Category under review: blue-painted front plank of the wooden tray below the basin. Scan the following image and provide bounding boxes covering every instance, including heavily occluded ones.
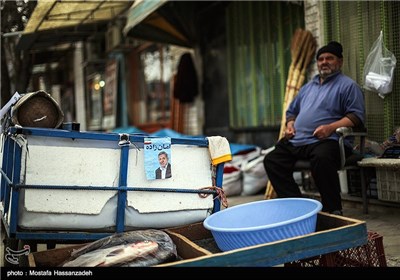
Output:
[165,224,367,267]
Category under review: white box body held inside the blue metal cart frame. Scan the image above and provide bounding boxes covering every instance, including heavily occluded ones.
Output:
[14,132,214,229]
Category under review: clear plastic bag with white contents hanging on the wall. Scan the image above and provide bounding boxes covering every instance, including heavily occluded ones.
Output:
[364,31,396,98]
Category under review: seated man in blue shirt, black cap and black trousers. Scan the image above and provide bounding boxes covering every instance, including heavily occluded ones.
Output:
[264,41,365,215]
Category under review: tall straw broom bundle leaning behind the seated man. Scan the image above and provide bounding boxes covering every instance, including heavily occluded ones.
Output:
[265,28,316,199]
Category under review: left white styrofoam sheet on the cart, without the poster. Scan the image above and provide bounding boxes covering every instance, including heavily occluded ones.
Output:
[21,136,120,214]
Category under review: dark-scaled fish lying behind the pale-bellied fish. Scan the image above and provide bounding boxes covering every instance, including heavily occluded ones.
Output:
[61,229,178,266]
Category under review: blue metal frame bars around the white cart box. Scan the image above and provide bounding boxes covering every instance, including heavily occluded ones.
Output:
[0,127,224,262]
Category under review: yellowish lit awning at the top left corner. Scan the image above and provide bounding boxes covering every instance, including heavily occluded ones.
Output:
[18,0,133,50]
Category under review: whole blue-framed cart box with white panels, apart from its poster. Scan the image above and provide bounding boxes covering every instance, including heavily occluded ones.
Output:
[1,127,223,244]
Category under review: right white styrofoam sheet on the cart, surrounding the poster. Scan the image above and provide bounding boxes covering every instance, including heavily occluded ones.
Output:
[127,144,213,213]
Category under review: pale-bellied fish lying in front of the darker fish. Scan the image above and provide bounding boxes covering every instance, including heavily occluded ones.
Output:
[63,241,158,267]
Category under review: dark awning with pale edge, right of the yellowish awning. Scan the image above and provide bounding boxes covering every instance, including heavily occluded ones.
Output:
[123,0,192,47]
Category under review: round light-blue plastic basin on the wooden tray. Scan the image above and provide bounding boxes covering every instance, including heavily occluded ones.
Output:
[203,198,322,251]
